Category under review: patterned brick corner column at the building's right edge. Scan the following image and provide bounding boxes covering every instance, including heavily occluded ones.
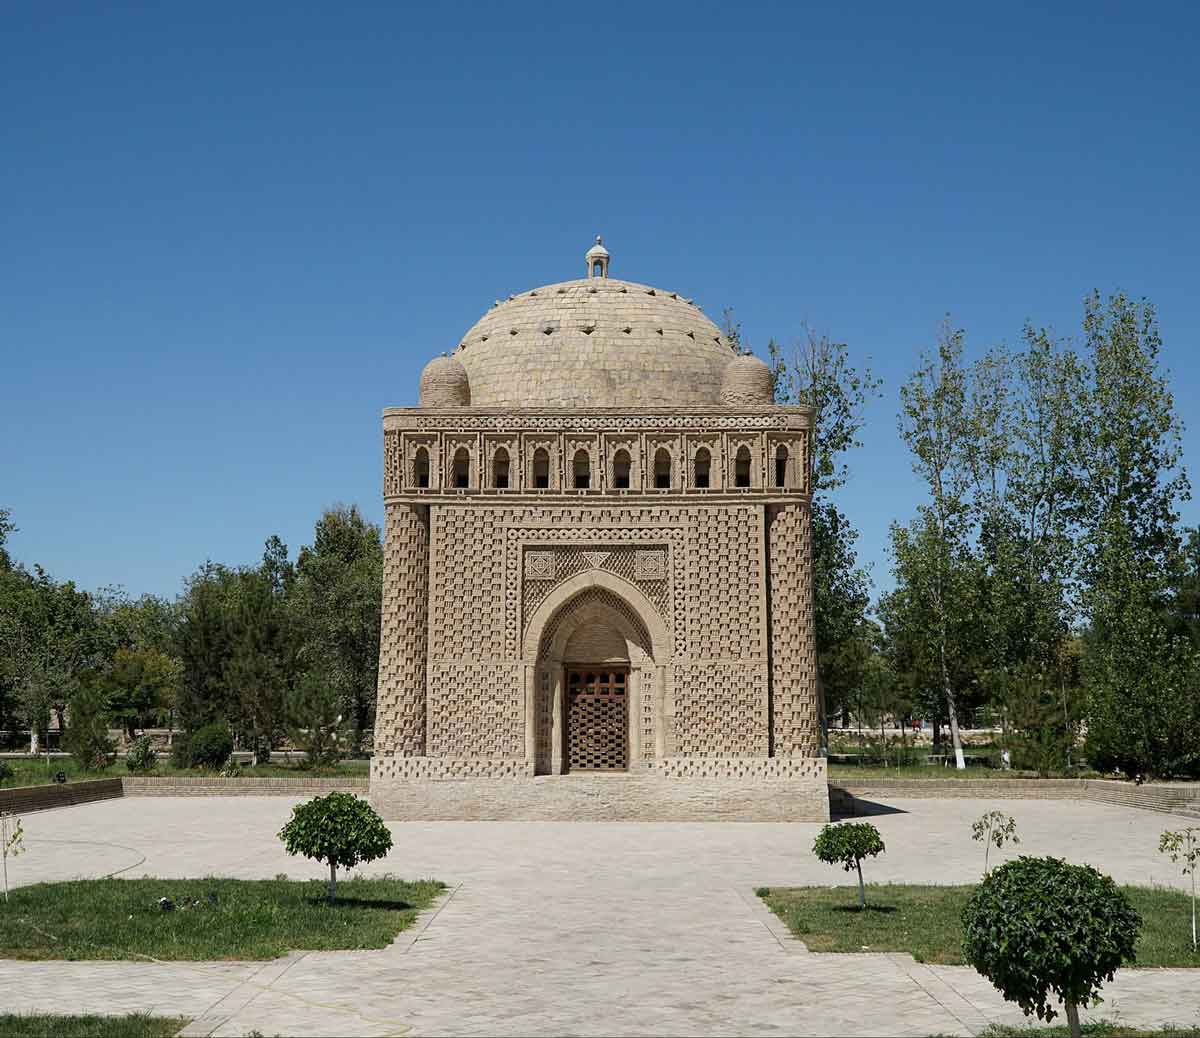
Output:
[767,504,820,757]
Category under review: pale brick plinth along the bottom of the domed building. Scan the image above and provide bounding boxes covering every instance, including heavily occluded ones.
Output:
[371,757,829,822]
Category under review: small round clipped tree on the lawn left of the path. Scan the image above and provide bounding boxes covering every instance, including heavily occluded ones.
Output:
[280,793,391,902]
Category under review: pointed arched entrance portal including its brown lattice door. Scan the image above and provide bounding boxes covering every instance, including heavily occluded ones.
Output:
[523,571,670,775]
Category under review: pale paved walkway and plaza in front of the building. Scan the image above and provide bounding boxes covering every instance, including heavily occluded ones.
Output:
[0,797,1200,1036]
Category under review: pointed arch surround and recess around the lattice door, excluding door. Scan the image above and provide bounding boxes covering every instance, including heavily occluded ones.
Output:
[521,570,671,775]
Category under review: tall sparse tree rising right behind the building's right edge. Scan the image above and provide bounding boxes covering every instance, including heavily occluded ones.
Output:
[768,328,882,724]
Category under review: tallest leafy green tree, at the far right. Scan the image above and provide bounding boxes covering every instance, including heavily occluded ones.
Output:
[1074,293,1200,775]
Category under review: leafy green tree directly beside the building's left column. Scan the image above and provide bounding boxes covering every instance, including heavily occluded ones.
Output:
[288,505,383,744]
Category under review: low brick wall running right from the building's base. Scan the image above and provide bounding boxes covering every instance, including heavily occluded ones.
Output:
[829,779,1200,817]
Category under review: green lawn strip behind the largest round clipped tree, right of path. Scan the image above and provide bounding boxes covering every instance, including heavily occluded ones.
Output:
[757,884,1200,967]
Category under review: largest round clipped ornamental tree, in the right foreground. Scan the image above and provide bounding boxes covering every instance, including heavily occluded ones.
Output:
[962,856,1141,1038]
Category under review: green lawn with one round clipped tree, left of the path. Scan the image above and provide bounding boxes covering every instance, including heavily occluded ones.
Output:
[0,877,445,960]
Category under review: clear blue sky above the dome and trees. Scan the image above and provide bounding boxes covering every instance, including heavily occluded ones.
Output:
[0,0,1200,595]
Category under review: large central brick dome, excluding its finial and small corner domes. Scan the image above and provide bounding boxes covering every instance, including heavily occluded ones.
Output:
[452,276,733,408]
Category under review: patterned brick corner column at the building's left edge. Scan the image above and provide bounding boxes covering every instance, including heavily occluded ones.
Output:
[374,504,430,760]
